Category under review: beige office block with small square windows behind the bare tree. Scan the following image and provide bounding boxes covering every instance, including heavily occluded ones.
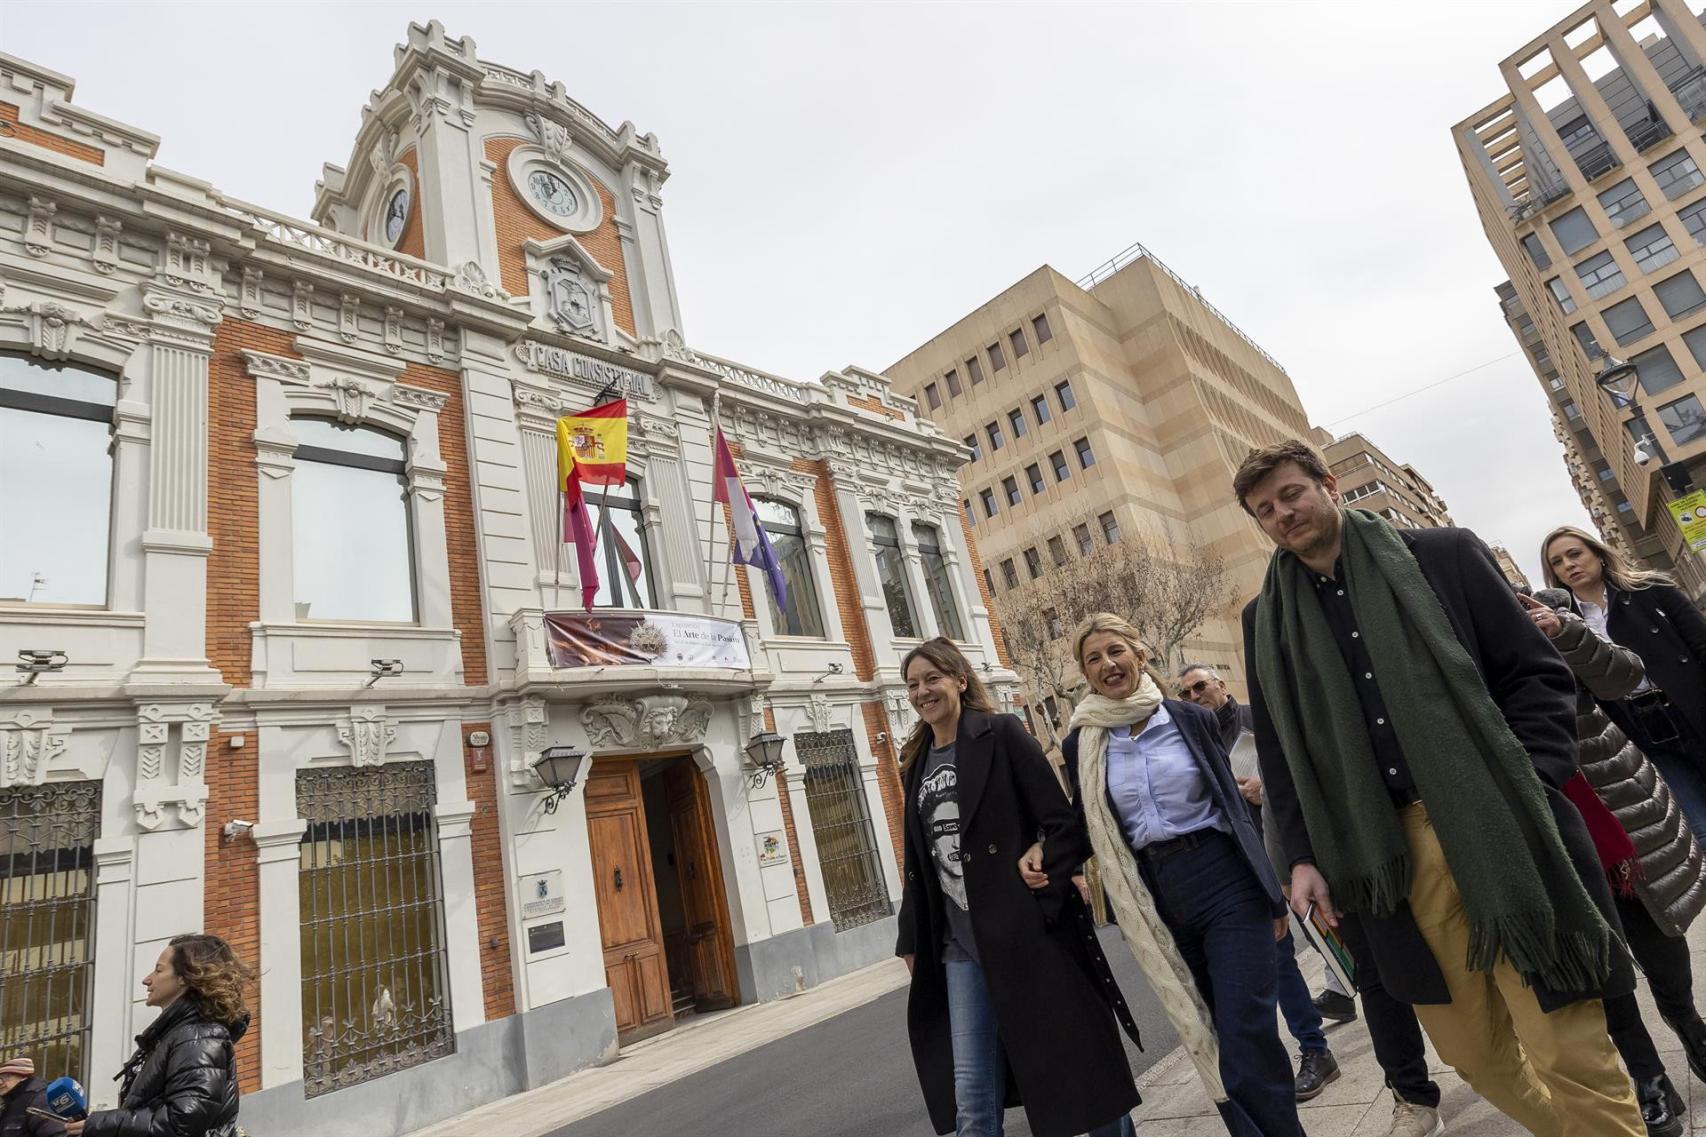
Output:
[887,246,1310,683]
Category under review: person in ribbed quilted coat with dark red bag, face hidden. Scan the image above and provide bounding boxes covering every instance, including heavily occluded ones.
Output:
[1523,589,1706,1134]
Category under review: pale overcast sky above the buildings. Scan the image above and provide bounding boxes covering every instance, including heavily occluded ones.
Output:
[0,0,1585,575]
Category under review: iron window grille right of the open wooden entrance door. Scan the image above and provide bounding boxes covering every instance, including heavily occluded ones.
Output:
[793,731,894,932]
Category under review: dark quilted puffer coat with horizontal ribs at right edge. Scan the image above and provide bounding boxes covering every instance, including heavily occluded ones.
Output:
[1552,611,1706,936]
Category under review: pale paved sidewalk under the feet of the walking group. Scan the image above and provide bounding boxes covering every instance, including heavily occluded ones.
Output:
[1131,922,1706,1137]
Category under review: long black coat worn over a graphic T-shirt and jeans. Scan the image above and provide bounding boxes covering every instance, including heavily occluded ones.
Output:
[894,710,1141,1137]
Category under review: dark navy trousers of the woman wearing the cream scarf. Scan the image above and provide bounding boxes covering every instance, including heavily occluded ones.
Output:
[1138,830,1303,1137]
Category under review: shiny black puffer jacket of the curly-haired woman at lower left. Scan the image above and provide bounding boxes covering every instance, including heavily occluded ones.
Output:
[84,997,249,1137]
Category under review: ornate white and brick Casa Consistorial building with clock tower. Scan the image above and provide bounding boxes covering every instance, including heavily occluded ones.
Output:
[0,24,1015,1137]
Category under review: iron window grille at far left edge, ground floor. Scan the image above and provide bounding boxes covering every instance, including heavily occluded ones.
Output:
[0,782,101,1084]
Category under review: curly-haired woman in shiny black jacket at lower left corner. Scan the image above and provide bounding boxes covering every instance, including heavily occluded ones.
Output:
[65,936,251,1137]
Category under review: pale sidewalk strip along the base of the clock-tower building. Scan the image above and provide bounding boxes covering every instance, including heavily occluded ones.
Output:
[409,959,908,1137]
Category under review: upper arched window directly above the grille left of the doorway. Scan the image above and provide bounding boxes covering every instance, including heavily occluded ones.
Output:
[290,418,415,623]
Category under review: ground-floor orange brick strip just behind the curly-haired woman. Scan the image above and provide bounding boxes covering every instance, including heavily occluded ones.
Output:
[203,727,259,1094]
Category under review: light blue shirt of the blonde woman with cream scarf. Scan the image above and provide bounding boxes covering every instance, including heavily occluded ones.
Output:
[1107,707,1228,848]
